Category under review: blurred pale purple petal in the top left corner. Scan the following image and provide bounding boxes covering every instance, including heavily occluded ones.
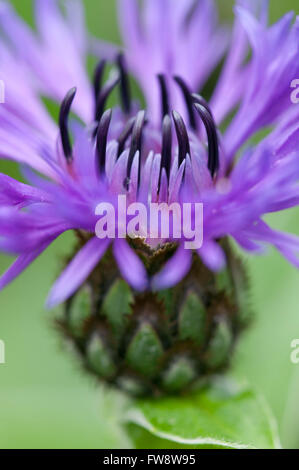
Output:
[0,0,93,122]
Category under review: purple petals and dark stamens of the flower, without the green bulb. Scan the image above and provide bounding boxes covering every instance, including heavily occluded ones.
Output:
[0,0,299,307]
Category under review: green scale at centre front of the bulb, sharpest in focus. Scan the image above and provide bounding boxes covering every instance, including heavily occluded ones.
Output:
[126,323,163,377]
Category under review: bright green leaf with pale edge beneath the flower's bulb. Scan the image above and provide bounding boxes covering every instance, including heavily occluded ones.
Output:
[125,379,280,449]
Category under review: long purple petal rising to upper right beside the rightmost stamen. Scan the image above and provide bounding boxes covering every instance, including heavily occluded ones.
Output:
[224,7,299,161]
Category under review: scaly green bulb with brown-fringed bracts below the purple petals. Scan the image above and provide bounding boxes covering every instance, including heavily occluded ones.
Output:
[57,240,250,396]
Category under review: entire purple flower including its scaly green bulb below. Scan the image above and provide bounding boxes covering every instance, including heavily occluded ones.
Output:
[0,0,299,393]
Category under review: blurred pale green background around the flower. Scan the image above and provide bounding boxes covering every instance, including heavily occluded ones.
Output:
[0,0,299,448]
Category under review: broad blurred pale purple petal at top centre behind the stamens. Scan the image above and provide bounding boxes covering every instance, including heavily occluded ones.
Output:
[118,0,228,124]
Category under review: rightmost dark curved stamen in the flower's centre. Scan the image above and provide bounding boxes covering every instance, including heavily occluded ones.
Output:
[194,103,219,178]
